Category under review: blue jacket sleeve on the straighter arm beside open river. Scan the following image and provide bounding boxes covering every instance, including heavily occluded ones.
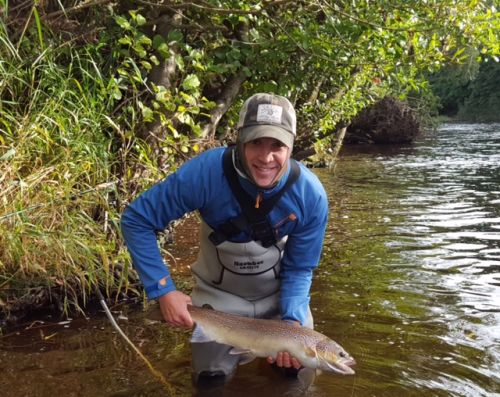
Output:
[280,176,328,325]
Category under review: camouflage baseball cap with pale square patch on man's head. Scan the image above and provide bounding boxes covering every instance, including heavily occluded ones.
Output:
[236,93,297,148]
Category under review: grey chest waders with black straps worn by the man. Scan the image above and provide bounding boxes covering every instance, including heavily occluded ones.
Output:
[191,147,312,382]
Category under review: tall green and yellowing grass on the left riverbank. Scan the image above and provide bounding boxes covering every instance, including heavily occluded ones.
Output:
[0,22,148,322]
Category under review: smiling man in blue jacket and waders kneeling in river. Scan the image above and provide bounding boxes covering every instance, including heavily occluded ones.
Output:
[121,94,328,382]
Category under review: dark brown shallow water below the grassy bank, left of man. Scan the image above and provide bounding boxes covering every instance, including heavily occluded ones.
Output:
[0,305,190,397]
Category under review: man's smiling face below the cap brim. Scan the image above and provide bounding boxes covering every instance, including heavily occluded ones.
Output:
[244,138,289,188]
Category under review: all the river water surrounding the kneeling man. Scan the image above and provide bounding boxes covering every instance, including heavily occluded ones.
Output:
[0,124,500,397]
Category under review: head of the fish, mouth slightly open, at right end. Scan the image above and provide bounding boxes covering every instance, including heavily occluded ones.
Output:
[316,339,356,375]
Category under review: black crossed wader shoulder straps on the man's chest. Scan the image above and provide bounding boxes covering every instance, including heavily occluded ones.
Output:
[209,146,300,247]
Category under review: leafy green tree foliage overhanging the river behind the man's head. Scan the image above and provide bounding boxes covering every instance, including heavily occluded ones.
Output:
[103,0,498,150]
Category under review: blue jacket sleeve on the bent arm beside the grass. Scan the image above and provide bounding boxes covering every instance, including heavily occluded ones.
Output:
[121,150,218,299]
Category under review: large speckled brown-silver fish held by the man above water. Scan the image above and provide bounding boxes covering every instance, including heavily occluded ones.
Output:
[188,305,356,375]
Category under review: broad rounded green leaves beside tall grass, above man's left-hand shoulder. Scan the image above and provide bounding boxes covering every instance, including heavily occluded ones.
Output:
[110,10,213,155]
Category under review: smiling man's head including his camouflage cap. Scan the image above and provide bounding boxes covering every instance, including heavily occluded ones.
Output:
[236,94,296,188]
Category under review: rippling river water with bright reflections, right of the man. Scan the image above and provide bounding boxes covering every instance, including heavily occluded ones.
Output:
[315,125,500,396]
